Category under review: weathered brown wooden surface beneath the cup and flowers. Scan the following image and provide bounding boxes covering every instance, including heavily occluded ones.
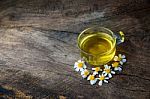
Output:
[0,0,150,99]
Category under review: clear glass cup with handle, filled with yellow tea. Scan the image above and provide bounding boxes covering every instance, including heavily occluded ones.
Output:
[77,27,124,66]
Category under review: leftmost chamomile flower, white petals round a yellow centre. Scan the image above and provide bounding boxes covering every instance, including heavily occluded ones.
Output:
[74,60,86,71]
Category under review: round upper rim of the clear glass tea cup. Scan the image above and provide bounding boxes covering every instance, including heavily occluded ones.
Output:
[77,26,116,56]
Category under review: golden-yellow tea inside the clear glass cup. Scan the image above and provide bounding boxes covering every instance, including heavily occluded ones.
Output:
[79,33,116,65]
